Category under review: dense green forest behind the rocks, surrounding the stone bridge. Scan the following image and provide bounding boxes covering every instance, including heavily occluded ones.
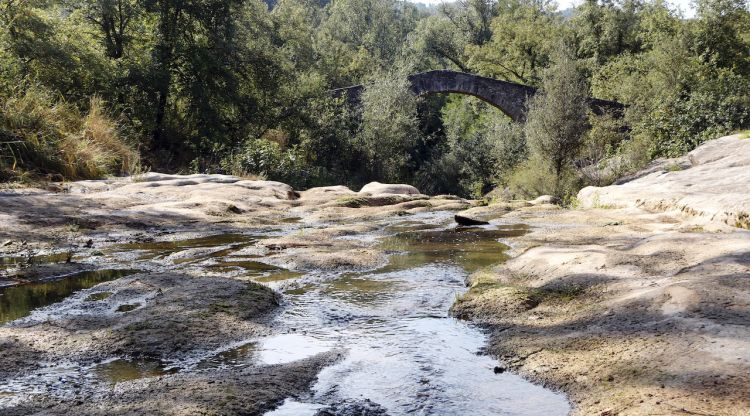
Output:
[0,0,750,197]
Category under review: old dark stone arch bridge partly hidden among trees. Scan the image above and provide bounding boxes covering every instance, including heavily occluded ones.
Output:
[332,70,624,121]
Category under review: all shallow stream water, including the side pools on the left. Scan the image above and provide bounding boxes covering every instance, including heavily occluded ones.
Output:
[0,213,570,416]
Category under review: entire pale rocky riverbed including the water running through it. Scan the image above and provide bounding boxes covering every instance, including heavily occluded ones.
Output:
[0,137,750,415]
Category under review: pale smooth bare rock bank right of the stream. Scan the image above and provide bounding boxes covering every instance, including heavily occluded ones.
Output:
[452,138,750,415]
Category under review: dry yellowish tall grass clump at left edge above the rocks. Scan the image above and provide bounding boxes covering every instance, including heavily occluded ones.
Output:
[0,87,140,180]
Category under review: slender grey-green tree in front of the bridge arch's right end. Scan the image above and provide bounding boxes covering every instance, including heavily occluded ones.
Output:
[525,47,588,196]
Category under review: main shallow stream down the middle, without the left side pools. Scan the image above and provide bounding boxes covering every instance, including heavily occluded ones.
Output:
[257,216,569,415]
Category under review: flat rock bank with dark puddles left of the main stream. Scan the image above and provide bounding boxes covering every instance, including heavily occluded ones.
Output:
[0,173,482,415]
